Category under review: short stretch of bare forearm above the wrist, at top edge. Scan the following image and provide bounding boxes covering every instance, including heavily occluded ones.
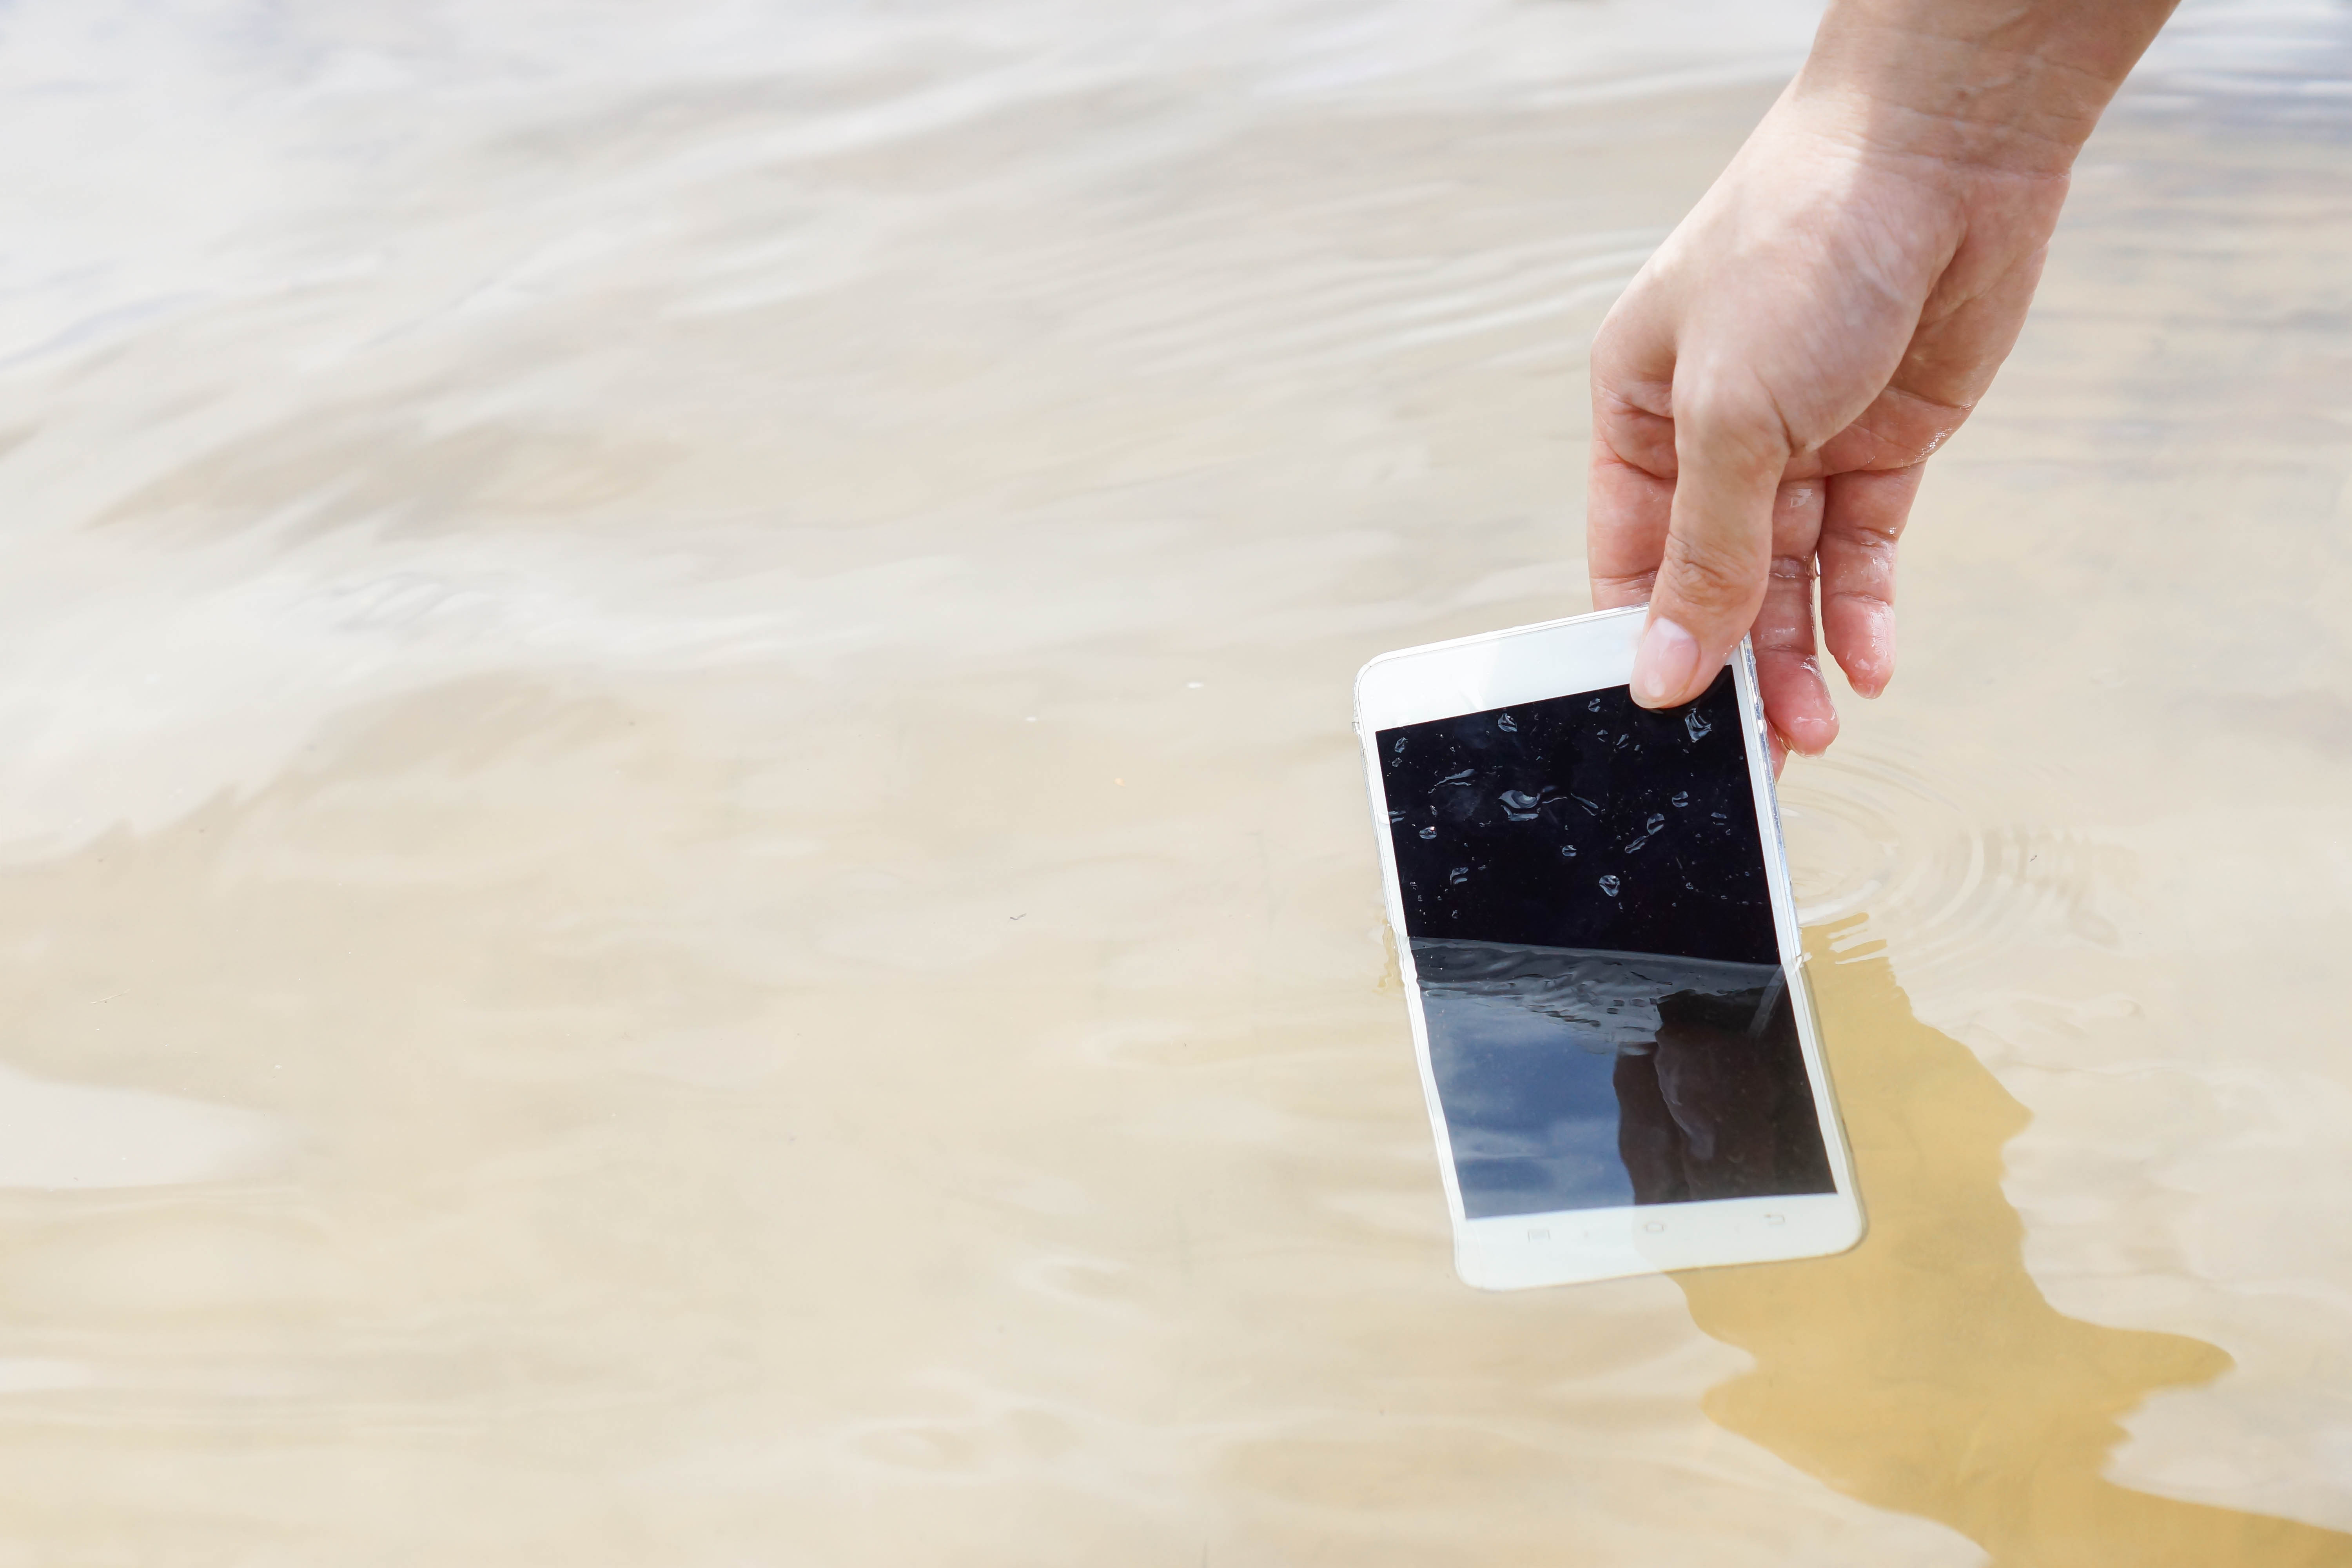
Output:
[1790,0,2176,176]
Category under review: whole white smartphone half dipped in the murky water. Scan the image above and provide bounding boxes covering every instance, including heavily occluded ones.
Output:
[1355,609,1863,1290]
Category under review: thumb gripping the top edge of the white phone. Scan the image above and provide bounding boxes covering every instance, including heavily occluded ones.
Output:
[1632,388,1790,708]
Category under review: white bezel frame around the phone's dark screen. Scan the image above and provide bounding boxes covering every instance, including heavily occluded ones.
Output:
[1355,606,1863,1290]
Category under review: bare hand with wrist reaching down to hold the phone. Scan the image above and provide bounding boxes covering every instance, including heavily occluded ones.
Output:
[1585,0,2171,766]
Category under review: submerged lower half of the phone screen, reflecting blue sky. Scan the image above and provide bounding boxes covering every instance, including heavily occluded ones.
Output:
[1414,938,1835,1220]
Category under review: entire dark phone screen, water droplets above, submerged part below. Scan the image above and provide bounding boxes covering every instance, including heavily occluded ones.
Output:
[1378,670,1837,1220]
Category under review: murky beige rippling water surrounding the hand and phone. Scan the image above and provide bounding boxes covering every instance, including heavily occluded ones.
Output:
[0,0,2352,1568]
